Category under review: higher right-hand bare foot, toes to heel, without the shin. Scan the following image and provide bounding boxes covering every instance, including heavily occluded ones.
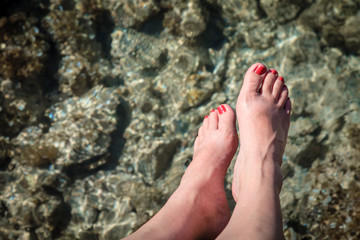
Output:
[232,63,291,201]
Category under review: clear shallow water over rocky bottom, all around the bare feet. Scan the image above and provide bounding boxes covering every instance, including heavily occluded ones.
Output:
[0,1,360,239]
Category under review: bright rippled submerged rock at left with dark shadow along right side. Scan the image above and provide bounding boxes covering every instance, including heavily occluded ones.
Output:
[15,86,119,166]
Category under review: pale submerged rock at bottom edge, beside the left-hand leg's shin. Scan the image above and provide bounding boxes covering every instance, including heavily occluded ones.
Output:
[67,172,164,239]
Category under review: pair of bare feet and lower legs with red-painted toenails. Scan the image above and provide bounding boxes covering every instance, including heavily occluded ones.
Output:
[127,63,291,239]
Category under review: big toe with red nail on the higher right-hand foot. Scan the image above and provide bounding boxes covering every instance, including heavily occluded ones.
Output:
[241,63,266,93]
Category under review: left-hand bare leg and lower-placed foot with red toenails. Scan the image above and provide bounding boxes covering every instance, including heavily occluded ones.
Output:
[126,104,238,239]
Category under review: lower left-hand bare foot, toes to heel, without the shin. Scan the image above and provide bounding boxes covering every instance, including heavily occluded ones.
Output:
[174,104,239,239]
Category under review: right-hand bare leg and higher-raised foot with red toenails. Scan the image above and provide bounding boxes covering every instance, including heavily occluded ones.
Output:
[219,63,291,239]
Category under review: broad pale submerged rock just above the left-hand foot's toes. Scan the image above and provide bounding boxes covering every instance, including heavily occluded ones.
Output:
[112,27,220,110]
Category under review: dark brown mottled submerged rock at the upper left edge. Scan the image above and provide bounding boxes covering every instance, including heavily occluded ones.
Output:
[0,12,49,79]
